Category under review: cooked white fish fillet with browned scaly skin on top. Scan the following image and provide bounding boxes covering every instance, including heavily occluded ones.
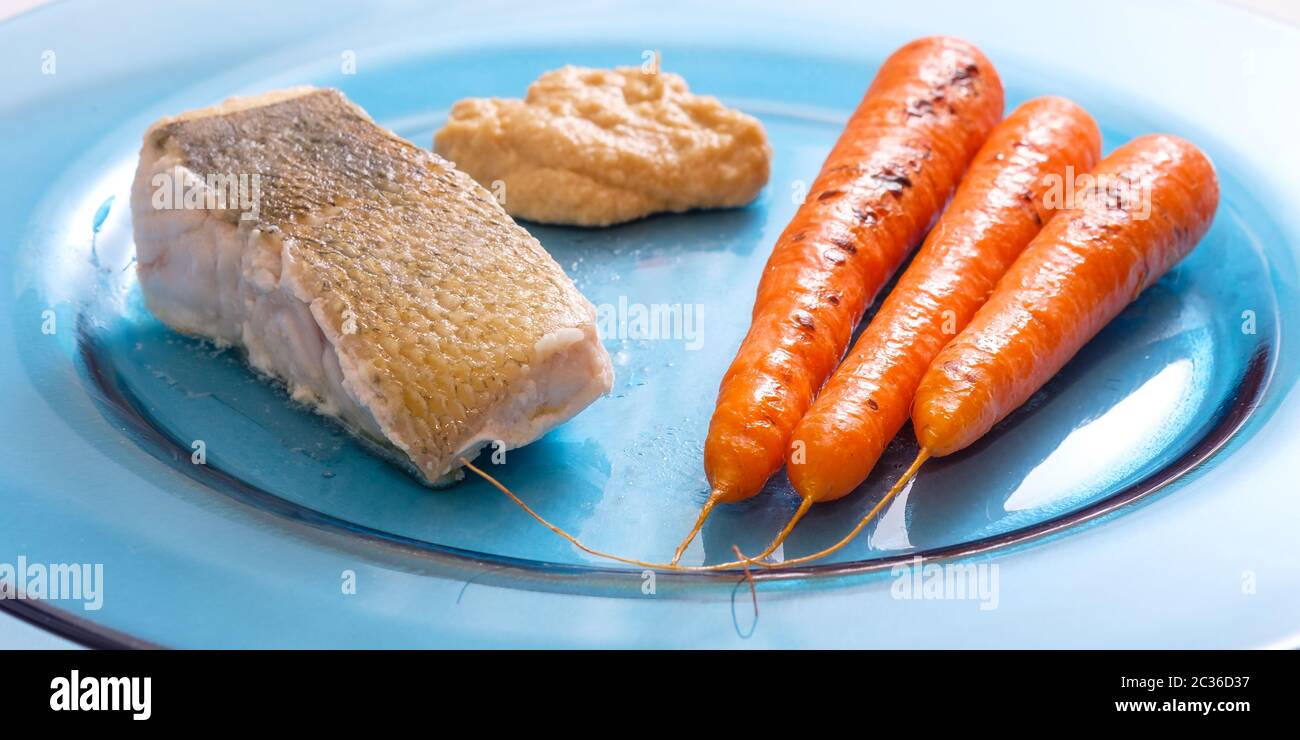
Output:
[131,87,614,485]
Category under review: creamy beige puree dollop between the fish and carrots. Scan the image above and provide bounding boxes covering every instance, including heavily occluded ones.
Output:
[434,66,772,226]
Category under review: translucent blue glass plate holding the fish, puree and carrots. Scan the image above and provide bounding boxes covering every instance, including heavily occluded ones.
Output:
[0,3,1300,646]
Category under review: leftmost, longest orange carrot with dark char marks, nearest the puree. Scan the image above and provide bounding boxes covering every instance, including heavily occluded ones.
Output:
[672,36,1002,563]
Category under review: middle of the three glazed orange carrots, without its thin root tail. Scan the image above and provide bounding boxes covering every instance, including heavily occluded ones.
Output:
[775,98,1101,507]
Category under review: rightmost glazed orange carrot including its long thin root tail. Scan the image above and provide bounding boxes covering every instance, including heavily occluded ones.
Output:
[759,135,1218,567]
